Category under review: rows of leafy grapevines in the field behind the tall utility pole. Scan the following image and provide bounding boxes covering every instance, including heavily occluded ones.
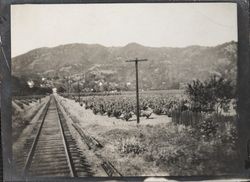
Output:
[64,91,187,116]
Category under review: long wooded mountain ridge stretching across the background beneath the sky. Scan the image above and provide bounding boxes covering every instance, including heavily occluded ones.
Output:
[12,41,237,89]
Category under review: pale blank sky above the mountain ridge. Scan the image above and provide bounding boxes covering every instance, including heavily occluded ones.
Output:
[11,3,237,57]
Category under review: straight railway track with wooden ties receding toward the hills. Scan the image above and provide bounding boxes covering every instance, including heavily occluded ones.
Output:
[17,96,93,177]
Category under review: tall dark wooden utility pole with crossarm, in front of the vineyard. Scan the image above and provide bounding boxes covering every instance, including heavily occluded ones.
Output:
[126,58,147,124]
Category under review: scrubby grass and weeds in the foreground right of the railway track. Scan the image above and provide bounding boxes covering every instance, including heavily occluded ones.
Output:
[98,123,237,175]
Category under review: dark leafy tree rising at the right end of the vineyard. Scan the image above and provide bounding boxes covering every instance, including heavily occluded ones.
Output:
[186,76,236,112]
